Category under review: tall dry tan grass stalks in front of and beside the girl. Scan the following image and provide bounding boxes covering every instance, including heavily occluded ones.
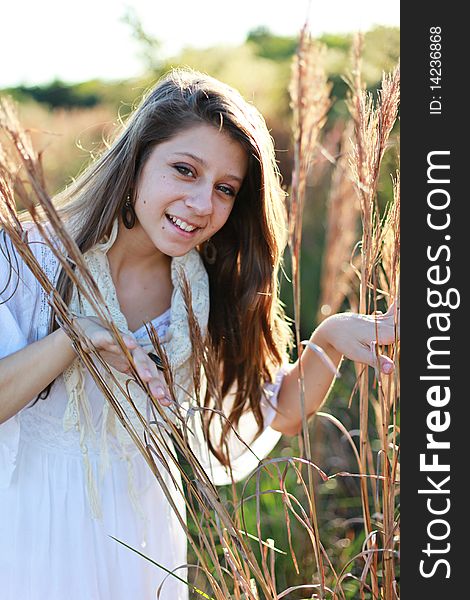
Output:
[0,27,400,600]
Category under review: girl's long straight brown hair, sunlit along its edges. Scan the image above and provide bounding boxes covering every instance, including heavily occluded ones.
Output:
[46,69,290,463]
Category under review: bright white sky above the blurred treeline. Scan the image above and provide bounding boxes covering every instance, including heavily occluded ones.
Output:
[0,0,400,88]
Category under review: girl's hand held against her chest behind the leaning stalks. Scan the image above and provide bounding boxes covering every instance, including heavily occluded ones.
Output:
[73,317,171,406]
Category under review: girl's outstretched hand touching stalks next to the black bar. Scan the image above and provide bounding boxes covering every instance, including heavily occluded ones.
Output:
[316,303,400,375]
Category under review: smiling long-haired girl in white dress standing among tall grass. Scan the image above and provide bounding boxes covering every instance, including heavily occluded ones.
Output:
[0,70,395,600]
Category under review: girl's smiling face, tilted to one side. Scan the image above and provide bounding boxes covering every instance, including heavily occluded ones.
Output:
[132,124,248,256]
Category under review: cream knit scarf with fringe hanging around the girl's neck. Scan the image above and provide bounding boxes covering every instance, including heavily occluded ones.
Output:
[63,220,209,516]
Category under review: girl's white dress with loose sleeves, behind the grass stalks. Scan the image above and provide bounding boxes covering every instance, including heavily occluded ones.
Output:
[0,226,283,600]
